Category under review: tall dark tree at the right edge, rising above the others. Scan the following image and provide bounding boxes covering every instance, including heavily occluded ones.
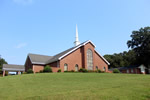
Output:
[127,27,150,66]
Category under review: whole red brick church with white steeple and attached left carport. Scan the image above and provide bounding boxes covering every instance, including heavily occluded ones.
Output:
[3,26,109,76]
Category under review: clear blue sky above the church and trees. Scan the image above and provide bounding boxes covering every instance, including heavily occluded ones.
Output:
[0,0,150,64]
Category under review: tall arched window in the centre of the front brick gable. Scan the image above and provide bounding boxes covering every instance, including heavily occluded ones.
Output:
[87,49,93,70]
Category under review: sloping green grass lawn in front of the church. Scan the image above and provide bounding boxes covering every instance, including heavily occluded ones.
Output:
[0,73,150,100]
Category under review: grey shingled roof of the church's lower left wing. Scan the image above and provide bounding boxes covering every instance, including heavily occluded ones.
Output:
[28,54,53,64]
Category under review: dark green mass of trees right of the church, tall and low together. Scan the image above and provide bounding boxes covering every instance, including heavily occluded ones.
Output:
[104,27,150,68]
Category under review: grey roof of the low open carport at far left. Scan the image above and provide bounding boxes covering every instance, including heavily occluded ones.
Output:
[2,64,25,71]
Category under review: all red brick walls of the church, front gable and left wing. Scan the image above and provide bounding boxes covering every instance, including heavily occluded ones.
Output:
[26,42,108,72]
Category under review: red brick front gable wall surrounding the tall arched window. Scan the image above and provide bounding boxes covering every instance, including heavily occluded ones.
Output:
[60,43,108,72]
